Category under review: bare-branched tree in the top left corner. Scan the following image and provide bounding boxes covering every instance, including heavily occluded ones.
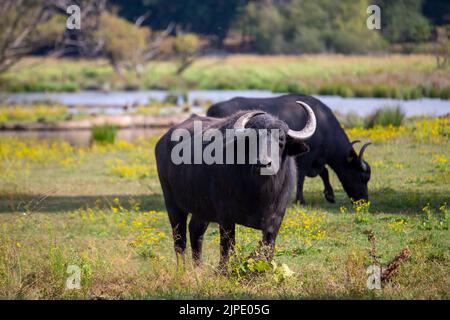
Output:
[0,0,106,72]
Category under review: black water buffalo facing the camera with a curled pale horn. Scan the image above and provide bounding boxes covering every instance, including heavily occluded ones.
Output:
[155,103,316,267]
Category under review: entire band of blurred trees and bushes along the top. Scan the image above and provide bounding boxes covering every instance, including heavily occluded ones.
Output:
[0,0,450,62]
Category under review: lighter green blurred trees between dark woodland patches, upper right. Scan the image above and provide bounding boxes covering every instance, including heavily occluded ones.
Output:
[237,0,383,54]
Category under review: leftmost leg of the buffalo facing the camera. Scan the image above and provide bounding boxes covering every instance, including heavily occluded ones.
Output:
[166,203,187,267]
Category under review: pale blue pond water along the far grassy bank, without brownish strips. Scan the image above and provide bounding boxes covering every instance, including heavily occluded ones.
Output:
[0,90,450,116]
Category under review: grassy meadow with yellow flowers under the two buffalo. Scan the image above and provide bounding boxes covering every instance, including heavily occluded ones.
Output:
[0,118,450,299]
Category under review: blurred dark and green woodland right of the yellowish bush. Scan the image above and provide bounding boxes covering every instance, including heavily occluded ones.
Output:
[110,0,450,54]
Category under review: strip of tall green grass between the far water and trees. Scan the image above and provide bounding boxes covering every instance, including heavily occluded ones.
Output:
[0,55,450,99]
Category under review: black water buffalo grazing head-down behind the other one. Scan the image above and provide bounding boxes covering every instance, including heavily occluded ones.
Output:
[207,94,370,204]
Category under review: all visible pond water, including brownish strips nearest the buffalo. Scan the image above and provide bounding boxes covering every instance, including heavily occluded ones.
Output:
[0,90,450,145]
